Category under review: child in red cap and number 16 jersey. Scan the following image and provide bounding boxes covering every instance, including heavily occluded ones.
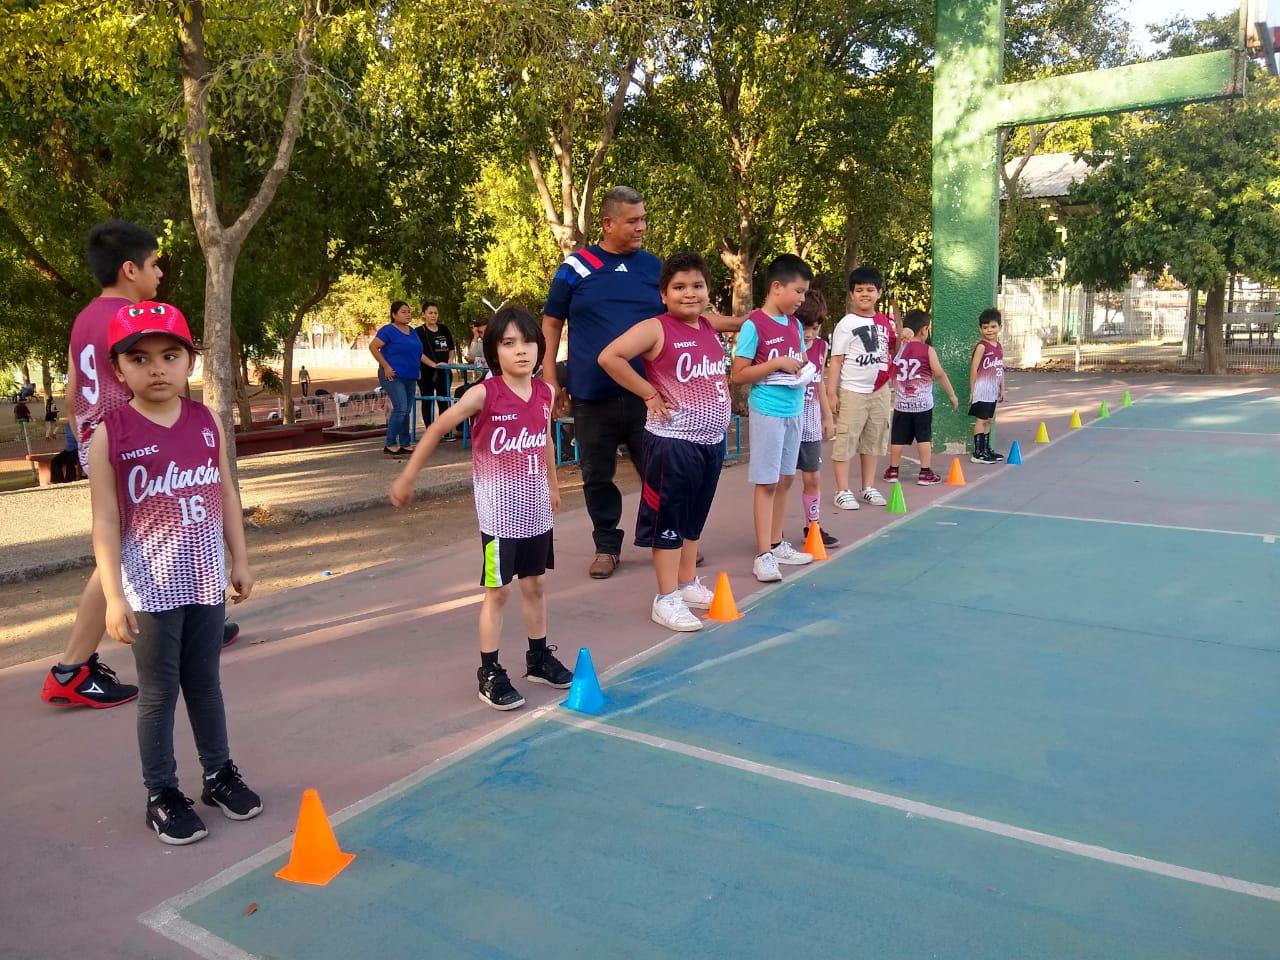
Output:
[90,301,262,845]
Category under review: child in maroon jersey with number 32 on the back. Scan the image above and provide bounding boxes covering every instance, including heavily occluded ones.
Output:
[884,310,960,486]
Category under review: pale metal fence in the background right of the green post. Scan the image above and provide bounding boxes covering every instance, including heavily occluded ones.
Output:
[997,276,1280,372]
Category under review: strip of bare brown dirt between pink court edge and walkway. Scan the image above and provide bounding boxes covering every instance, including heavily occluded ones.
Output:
[0,471,629,667]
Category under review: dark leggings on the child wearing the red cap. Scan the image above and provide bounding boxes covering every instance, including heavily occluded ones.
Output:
[133,603,230,795]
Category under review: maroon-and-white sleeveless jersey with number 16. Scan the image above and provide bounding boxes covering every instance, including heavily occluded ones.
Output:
[102,398,227,613]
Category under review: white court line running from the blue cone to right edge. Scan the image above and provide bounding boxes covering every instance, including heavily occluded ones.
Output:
[556,713,1280,902]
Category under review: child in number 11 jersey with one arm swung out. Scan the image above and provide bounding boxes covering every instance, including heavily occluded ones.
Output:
[390,307,573,710]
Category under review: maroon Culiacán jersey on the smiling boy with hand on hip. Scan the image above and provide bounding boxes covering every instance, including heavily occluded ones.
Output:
[644,314,730,444]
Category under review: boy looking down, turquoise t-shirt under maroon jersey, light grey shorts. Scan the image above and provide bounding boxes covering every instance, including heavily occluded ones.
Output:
[732,253,813,582]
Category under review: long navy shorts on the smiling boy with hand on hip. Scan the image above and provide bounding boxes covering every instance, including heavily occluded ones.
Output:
[635,430,724,550]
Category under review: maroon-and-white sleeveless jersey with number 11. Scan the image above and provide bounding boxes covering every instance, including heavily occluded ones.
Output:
[471,376,553,538]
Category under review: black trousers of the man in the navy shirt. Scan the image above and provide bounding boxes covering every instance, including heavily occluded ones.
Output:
[573,393,648,557]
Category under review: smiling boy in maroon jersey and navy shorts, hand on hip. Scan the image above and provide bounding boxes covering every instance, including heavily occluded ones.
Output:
[599,252,741,631]
